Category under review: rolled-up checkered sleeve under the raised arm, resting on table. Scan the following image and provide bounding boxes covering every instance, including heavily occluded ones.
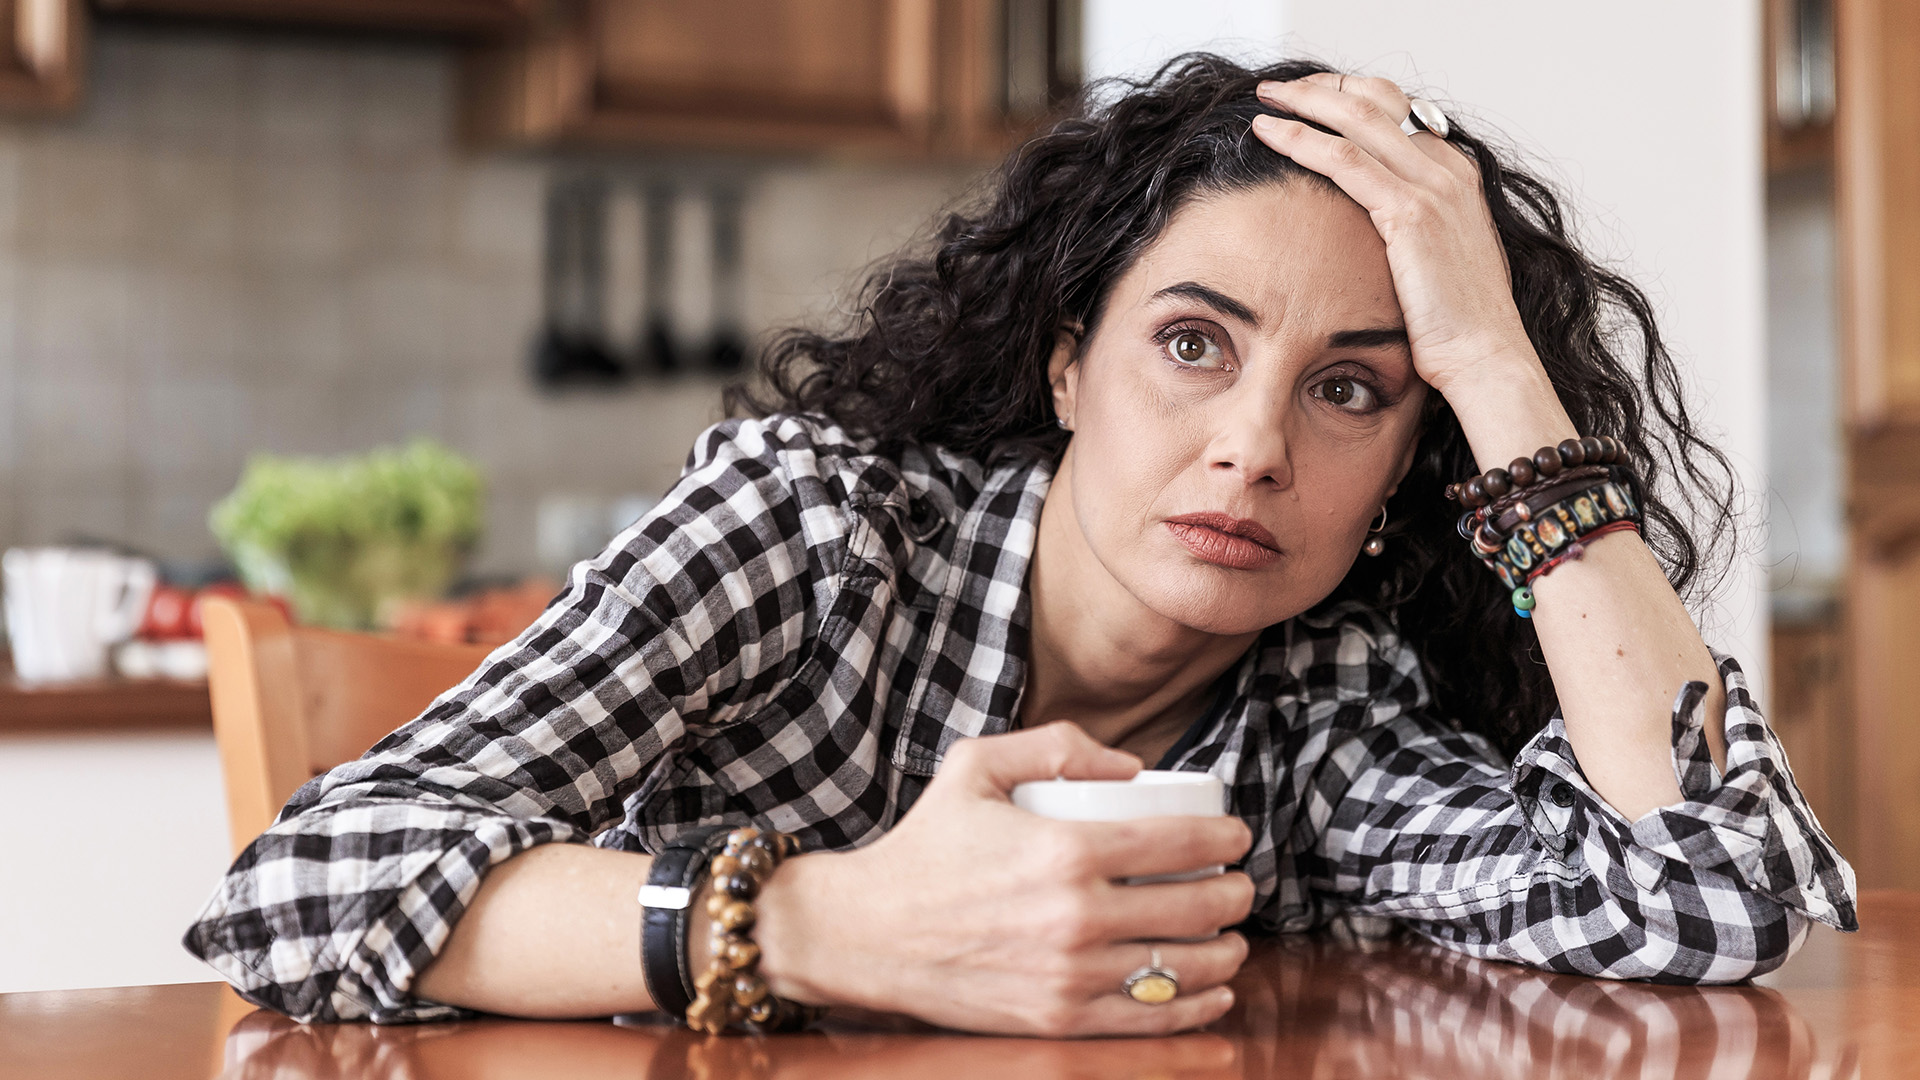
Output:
[1315,655,1857,982]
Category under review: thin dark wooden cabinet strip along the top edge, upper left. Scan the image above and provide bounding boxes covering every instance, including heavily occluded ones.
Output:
[94,0,547,37]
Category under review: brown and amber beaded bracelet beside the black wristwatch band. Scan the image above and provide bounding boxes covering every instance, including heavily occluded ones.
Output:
[687,826,826,1036]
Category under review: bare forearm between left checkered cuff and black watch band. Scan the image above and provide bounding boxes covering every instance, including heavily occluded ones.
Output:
[413,844,672,1019]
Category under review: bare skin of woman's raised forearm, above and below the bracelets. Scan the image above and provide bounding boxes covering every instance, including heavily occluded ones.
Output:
[1448,356,1726,821]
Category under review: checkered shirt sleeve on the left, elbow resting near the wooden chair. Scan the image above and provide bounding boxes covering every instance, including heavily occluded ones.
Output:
[184,421,833,1022]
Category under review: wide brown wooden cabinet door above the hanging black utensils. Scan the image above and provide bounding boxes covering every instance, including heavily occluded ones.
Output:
[467,0,939,150]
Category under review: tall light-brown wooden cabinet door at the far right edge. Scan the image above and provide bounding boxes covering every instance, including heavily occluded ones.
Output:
[1834,0,1920,890]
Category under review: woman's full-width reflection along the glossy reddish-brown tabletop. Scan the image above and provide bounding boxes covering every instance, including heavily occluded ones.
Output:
[214,938,1860,1080]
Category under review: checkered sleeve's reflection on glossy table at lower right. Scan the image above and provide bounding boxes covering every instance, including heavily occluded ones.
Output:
[1227,940,1860,1078]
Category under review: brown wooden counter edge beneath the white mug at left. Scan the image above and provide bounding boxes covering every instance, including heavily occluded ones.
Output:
[0,653,213,736]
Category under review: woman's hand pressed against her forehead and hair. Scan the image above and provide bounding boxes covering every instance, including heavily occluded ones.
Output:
[1254,75,1540,398]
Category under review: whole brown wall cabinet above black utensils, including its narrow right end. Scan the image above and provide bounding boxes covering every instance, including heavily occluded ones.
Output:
[465,0,1077,156]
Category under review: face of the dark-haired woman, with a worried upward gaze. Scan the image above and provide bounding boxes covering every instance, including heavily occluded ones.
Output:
[1048,181,1427,634]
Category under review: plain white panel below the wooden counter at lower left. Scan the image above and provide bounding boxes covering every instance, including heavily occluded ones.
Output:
[0,734,228,994]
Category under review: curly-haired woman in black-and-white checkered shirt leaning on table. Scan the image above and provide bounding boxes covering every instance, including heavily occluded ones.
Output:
[188,56,1855,1034]
